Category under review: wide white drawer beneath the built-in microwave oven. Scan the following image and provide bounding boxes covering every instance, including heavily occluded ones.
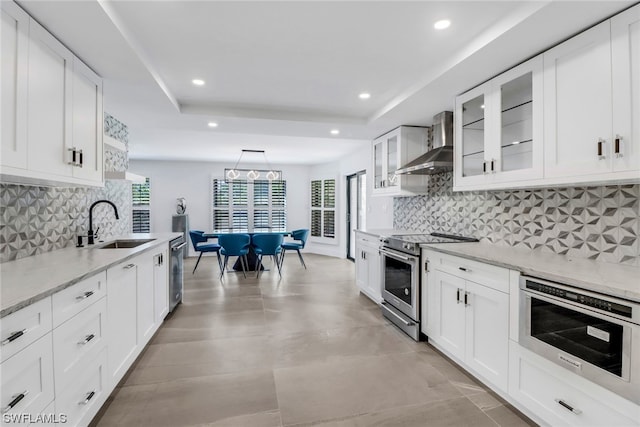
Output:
[509,342,638,426]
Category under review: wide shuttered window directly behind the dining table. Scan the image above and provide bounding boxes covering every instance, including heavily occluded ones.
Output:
[212,179,287,232]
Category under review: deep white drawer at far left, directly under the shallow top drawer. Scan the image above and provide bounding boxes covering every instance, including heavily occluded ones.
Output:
[0,333,53,422]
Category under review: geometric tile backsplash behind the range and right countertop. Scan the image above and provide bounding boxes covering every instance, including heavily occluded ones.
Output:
[393,172,640,266]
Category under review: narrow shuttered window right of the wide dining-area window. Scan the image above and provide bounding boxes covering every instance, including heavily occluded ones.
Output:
[311,179,336,239]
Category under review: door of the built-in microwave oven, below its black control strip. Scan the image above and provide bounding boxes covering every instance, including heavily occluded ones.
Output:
[519,289,640,403]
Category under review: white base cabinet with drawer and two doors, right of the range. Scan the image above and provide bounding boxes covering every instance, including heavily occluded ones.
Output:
[422,251,509,392]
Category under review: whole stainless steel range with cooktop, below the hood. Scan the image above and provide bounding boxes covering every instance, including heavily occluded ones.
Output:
[380,233,478,341]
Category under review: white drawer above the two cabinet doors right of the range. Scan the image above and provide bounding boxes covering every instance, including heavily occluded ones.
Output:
[432,254,509,294]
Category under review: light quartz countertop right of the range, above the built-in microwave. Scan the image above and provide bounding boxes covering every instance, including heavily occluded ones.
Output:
[421,241,640,302]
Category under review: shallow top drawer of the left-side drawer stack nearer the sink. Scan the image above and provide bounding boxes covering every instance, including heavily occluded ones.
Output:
[52,271,107,328]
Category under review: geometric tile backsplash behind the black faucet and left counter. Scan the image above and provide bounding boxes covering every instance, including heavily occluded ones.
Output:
[0,113,131,262]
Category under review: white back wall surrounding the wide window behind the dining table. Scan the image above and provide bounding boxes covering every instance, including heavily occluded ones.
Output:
[129,160,309,255]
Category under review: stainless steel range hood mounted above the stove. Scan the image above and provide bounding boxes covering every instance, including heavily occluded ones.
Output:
[396,111,453,175]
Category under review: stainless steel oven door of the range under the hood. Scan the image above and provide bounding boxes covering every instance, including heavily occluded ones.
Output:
[380,248,420,321]
